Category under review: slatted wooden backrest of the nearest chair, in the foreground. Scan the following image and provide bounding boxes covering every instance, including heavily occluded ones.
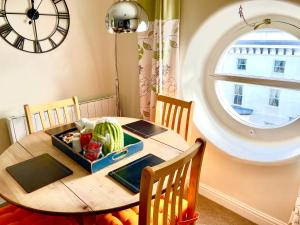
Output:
[139,138,206,225]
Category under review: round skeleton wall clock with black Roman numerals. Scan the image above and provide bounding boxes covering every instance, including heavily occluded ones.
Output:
[0,0,70,53]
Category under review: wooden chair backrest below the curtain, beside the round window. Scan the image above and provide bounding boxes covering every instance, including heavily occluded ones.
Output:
[153,95,193,140]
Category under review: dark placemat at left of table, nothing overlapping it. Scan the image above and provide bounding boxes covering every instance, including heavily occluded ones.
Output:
[6,153,73,193]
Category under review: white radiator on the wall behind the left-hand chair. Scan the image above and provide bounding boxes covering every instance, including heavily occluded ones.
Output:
[7,95,117,143]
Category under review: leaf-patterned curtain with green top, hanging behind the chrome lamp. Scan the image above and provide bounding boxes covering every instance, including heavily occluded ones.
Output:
[138,0,180,120]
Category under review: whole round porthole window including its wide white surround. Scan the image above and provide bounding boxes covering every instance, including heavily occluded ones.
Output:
[180,0,300,164]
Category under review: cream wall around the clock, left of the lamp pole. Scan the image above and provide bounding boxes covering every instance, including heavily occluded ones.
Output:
[0,0,114,151]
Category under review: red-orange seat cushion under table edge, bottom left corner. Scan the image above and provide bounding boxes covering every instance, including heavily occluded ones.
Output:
[0,205,78,225]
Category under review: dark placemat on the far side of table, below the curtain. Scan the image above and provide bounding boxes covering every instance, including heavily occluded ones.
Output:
[122,120,168,138]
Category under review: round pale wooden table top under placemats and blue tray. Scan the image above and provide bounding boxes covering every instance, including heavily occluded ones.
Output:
[0,117,188,214]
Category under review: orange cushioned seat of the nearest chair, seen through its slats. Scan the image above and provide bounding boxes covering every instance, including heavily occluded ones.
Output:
[97,195,188,225]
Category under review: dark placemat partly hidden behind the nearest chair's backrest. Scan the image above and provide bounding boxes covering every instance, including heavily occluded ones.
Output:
[108,154,165,193]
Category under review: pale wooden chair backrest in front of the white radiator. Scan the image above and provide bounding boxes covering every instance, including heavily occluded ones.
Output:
[24,96,80,134]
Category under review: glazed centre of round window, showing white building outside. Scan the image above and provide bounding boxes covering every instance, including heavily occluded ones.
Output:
[215,29,300,128]
